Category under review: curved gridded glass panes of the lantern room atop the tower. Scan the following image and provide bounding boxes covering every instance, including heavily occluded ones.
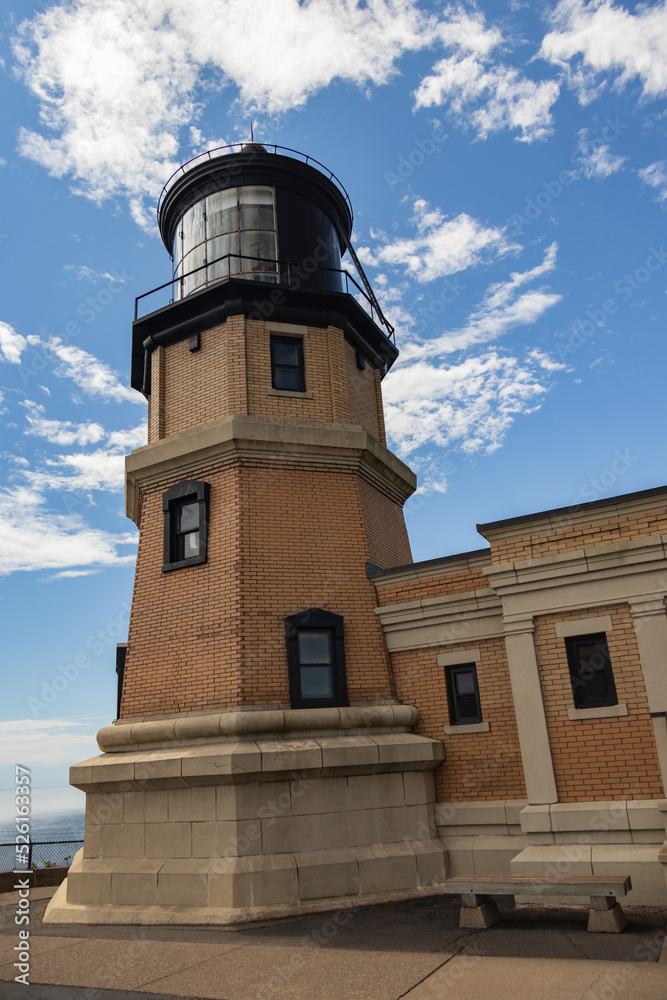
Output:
[174,185,279,299]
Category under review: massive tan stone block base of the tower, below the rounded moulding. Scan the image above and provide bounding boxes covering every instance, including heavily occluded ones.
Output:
[44,710,448,924]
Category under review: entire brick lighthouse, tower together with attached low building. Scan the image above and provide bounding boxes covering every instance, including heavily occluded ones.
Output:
[47,144,667,923]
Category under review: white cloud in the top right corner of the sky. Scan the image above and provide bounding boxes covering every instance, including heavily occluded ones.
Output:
[540,0,667,103]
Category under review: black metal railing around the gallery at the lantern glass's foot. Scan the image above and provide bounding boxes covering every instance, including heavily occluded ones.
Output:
[134,253,396,344]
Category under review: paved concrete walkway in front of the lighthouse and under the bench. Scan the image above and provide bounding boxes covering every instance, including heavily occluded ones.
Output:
[0,896,667,1000]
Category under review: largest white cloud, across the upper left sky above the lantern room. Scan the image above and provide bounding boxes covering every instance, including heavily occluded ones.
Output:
[14,0,434,228]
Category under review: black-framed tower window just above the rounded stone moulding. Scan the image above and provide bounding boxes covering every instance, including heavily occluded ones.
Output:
[285,608,349,708]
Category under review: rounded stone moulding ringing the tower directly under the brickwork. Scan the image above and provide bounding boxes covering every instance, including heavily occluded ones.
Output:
[97,705,419,753]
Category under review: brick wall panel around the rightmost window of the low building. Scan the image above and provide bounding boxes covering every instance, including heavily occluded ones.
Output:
[535,605,663,802]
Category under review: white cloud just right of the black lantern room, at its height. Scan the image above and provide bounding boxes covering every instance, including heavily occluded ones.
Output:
[359,198,519,282]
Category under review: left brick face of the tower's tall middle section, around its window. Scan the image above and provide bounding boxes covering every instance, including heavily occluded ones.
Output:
[121,464,243,718]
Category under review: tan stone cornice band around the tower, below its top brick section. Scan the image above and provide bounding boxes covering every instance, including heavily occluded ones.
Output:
[125,414,417,523]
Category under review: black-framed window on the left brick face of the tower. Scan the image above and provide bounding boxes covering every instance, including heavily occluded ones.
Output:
[162,479,210,573]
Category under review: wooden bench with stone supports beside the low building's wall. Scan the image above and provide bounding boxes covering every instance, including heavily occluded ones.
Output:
[445,875,632,934]
